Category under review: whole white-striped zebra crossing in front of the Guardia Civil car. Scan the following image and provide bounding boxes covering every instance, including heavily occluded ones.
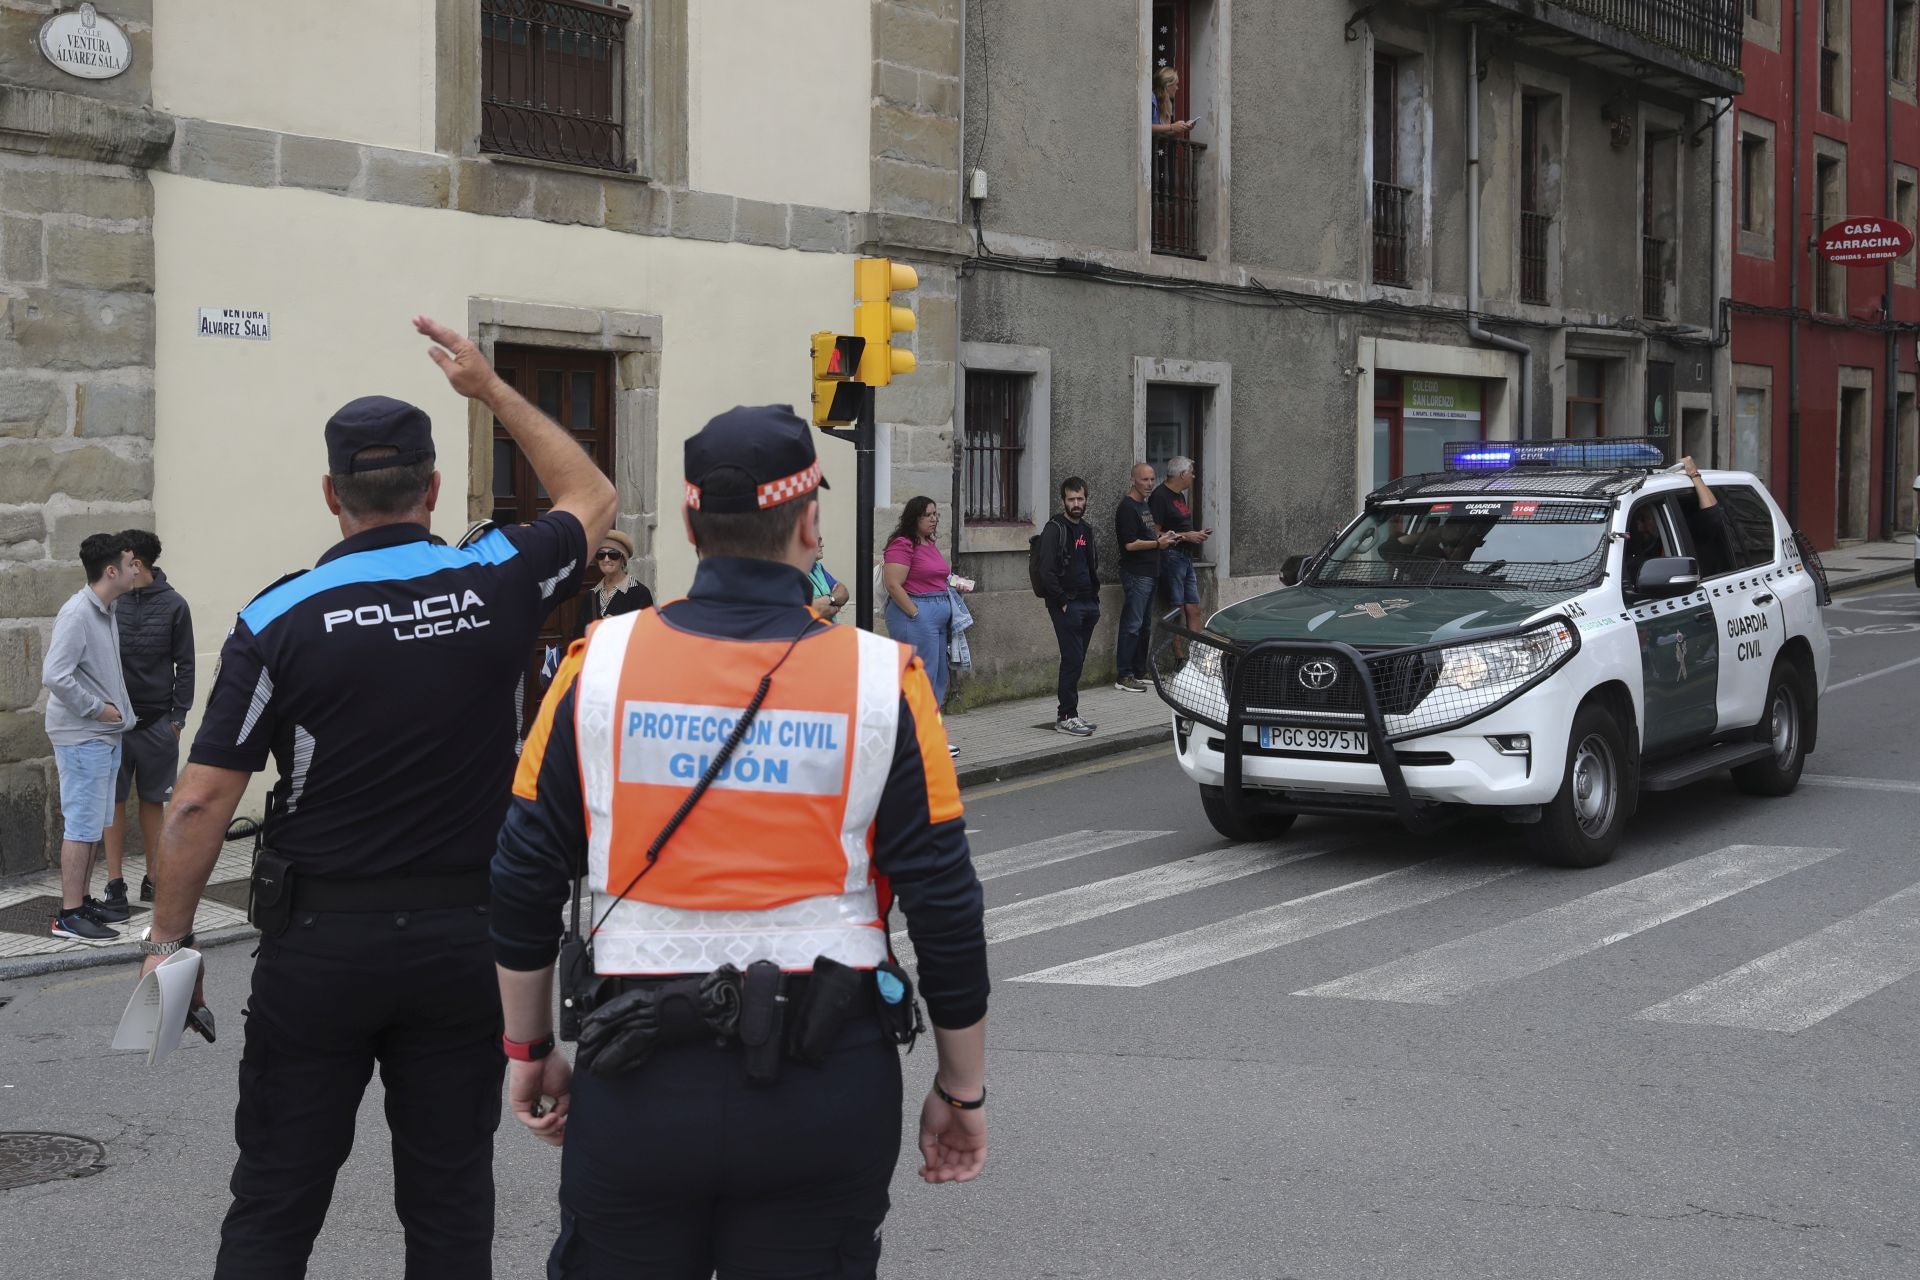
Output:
[910,831,1920,1034]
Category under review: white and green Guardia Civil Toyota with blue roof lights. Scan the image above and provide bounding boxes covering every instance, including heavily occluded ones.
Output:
[1154,439,1830,867]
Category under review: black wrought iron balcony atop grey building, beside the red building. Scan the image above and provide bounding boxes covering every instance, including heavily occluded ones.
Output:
[1413,0,1747,98]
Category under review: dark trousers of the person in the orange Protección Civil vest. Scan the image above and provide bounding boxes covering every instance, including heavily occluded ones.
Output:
[547,1023,900,1280]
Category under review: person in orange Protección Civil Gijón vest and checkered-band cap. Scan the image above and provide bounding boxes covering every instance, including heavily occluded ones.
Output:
[493,407,987,1278]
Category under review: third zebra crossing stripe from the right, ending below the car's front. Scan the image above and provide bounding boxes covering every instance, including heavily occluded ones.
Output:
[1014,858,1526,986]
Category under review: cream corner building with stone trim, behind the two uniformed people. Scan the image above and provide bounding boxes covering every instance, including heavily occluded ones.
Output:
[0,0,968,875]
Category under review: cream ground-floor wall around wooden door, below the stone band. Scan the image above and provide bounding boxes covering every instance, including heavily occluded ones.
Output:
[154,171,872,744]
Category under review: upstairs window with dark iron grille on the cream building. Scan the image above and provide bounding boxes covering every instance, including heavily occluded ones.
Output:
[480,0,634,171]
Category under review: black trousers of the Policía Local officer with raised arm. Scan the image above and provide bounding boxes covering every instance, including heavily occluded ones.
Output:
[213,908,507,1280]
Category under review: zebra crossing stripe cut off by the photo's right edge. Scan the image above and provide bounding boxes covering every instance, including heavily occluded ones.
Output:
[1634,885,1920,1034]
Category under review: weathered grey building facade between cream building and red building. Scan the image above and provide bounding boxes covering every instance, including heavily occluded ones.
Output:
[954,0,1741,699]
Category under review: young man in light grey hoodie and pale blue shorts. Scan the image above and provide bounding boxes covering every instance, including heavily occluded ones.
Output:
[40,533,152,942]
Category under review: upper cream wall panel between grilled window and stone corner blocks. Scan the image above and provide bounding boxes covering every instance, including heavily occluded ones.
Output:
[687,0,874,209]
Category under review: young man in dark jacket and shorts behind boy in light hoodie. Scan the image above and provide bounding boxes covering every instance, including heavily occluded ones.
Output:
[106,530,194,921]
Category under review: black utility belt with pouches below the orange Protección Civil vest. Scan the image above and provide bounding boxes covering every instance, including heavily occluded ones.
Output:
[563,956,924,1084]
